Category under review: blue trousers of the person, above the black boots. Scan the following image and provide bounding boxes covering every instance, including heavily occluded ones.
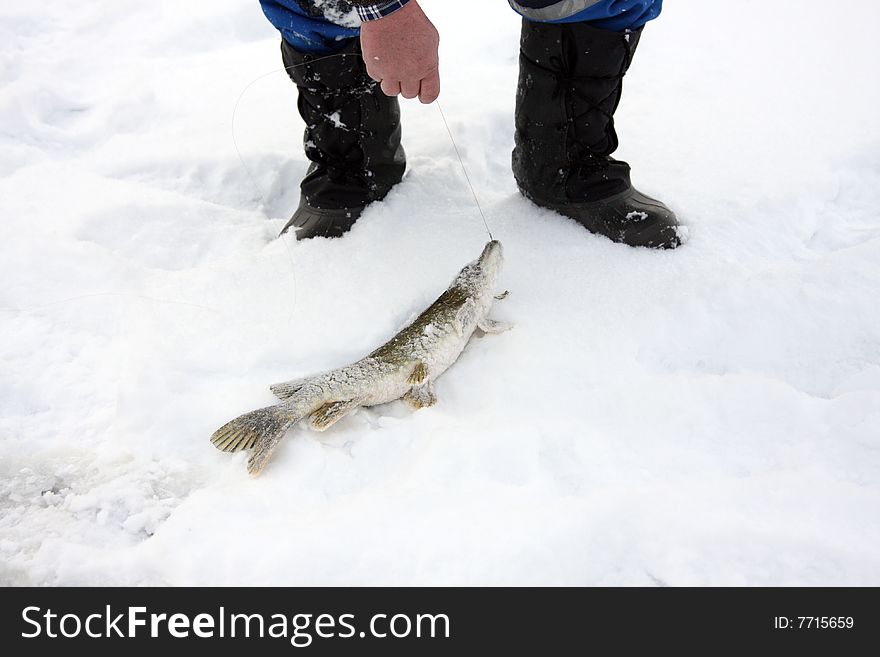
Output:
[260,0,663,55]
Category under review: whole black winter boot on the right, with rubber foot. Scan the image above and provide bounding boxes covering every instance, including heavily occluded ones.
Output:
[513,20,681,248]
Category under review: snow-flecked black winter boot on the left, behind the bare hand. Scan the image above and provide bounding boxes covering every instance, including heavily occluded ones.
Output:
[281,39,406,240]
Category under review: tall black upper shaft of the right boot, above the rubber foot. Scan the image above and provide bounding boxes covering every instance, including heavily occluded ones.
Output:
[513,20,641,202]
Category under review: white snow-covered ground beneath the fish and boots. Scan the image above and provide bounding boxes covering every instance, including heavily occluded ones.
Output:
[0,0,880,585]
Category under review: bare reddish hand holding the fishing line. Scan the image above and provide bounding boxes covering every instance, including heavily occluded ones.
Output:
[361,0,440,103]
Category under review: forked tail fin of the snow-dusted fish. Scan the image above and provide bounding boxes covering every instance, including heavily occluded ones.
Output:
[211,405,300,475]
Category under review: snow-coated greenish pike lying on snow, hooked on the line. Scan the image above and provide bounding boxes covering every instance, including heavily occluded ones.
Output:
[211,239,512,476]
